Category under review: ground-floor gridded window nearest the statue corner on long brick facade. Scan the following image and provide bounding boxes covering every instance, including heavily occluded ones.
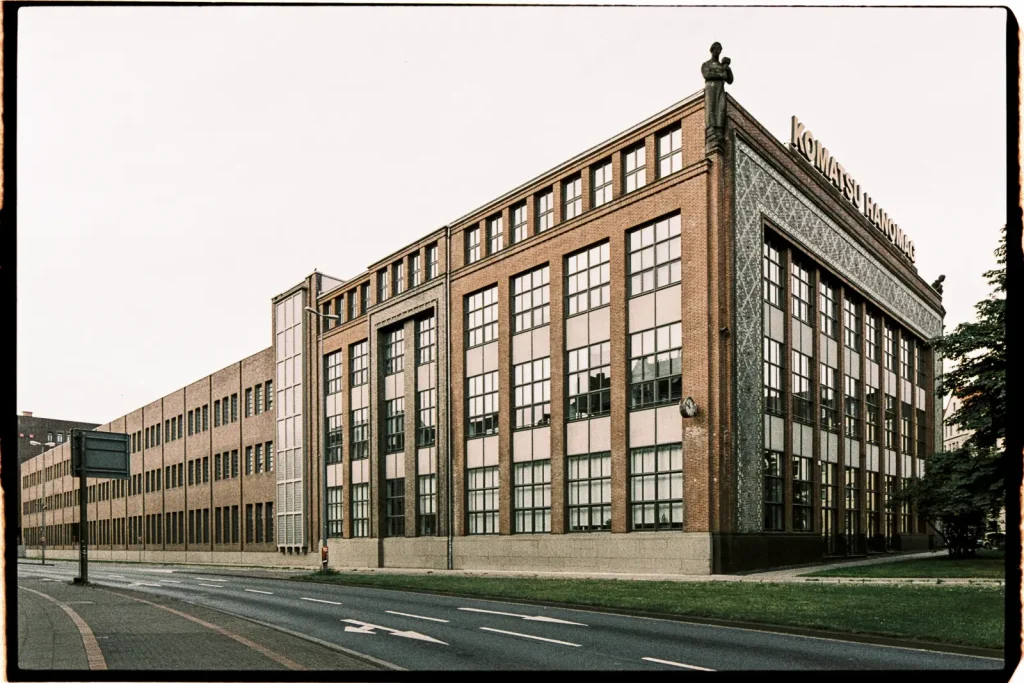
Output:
[630,443,683,530]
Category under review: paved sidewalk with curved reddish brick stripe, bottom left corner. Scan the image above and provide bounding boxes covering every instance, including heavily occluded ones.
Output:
[17,578,383,671]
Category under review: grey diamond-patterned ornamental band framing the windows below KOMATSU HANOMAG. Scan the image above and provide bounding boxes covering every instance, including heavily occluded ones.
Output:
[733,138,942,531]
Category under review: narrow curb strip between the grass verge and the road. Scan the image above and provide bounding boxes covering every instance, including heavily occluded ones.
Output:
[290,578,1006,660]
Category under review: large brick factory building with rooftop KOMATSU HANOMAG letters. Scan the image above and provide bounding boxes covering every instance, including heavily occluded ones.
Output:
[23,56,943,573]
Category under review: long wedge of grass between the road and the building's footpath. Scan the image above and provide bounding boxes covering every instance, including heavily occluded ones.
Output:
[292,571,1004,649]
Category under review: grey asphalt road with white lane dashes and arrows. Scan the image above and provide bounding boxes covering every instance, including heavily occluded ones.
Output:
[18,561,1004,671]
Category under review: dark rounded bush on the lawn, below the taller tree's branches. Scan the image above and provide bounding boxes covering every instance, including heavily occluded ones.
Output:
[901,446,1006,556]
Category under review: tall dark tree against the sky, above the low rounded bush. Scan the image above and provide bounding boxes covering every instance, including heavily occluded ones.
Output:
[935,226,1007,456]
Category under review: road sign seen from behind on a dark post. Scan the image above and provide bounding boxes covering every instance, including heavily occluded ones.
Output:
[71,429,131,586]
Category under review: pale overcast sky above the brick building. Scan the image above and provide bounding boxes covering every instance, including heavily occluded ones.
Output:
[17,6,1007,423]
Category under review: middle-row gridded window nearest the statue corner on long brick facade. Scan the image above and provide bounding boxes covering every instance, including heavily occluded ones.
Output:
[630,323,683,409]
